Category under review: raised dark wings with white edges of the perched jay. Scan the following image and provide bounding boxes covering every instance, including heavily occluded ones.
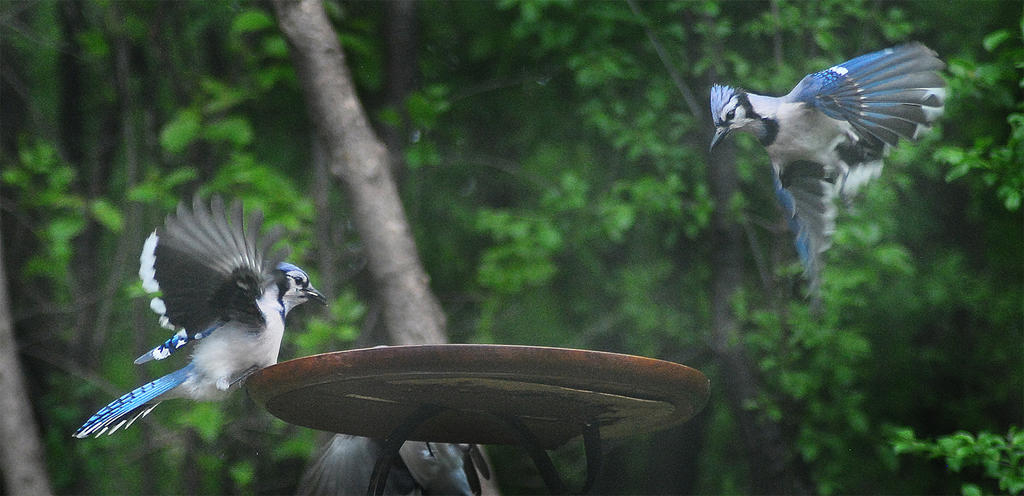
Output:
[135,197,285,364]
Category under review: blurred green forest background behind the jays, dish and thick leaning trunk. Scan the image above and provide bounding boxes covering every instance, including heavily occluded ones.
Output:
[0,0,1024,494]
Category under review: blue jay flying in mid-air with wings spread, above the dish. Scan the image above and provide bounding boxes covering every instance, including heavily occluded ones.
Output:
[711,43,946,294]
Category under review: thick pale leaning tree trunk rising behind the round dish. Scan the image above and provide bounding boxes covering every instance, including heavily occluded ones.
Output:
[273,0,446,344]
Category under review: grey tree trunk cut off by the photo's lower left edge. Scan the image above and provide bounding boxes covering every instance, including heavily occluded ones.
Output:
[0,211,53,495]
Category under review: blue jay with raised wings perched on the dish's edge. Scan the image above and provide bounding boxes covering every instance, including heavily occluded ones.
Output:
[75,197,327,438]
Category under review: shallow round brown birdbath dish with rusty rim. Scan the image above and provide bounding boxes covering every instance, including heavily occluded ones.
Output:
[246,344,709,448]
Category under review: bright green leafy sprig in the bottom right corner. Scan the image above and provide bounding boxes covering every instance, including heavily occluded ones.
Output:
[889,427,1024,496]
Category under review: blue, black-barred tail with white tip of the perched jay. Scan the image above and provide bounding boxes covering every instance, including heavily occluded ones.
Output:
[75,364,195,439]
